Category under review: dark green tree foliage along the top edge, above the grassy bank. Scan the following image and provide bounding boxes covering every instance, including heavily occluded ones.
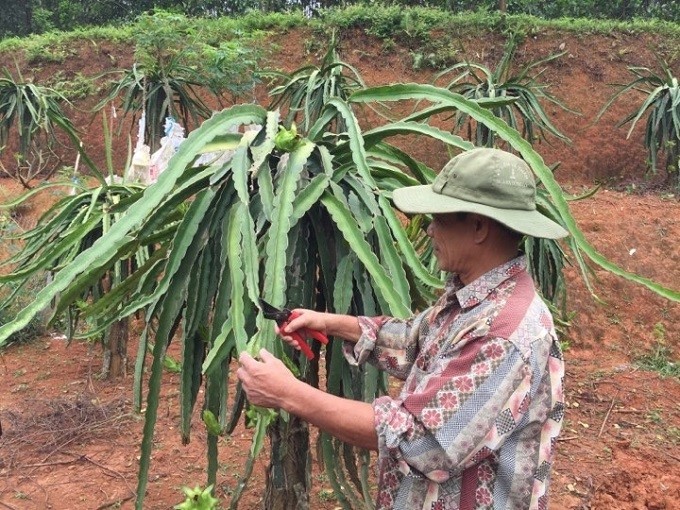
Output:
[0,0,680,39]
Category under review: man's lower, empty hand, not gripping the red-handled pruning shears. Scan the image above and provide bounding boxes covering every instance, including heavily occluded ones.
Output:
[236,349,299,409]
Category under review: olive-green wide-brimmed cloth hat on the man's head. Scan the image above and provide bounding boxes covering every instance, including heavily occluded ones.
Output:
[393,148,569,239]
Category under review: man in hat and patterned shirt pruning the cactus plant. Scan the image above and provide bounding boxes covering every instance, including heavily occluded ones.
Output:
[238,148,567,510]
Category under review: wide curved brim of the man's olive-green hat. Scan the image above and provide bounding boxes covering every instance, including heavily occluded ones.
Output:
[392,184,569,239]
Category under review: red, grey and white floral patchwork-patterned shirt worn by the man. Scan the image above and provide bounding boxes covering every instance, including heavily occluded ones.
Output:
[345,257,564,510]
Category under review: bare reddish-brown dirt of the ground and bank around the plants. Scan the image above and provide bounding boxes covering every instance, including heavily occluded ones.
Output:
[0,24,680,510]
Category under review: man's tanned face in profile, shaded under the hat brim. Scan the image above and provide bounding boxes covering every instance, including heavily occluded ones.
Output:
[427,213,474,274]
